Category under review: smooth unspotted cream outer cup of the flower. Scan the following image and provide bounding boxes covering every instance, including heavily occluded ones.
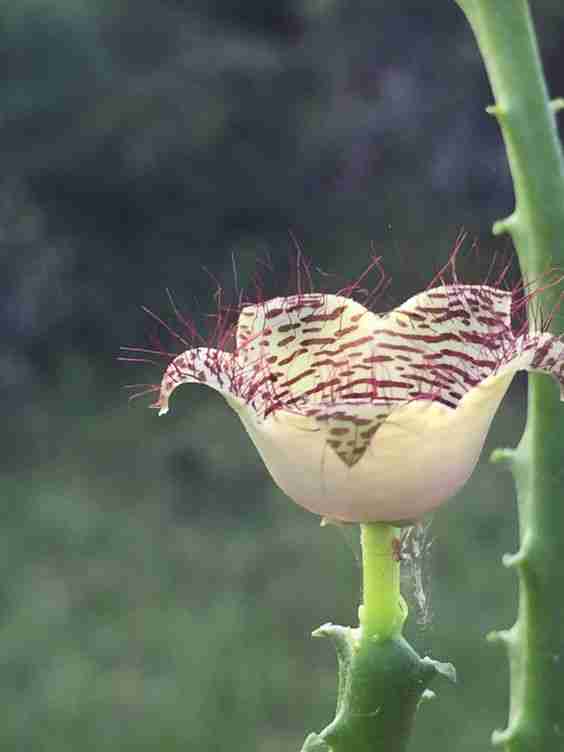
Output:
[235,374,512,522]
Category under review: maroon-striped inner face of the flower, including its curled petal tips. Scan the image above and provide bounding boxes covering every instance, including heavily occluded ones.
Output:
[157,284,564,482]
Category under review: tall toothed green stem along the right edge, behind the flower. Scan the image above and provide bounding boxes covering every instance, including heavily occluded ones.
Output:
[457,0,564,752]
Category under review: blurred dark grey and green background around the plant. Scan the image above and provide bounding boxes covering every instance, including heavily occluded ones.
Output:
[6,0,564,752]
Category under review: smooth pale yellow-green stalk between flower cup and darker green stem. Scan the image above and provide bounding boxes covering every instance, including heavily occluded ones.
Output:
[359,522,407,640]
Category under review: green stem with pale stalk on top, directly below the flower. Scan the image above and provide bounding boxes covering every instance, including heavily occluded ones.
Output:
[302,523,455,752]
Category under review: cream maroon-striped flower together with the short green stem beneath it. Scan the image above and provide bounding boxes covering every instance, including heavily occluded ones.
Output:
[155,274,564,752]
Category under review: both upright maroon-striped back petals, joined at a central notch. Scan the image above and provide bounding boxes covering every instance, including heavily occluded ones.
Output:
[228,285,513,428]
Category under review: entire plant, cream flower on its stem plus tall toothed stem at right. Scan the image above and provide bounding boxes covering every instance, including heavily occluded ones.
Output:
[130,0,564,752]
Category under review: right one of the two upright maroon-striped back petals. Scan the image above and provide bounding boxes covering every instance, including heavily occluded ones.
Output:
[362,284,514,408]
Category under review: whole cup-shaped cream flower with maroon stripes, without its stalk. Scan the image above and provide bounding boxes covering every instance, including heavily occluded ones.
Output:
[156,282,564,522]
